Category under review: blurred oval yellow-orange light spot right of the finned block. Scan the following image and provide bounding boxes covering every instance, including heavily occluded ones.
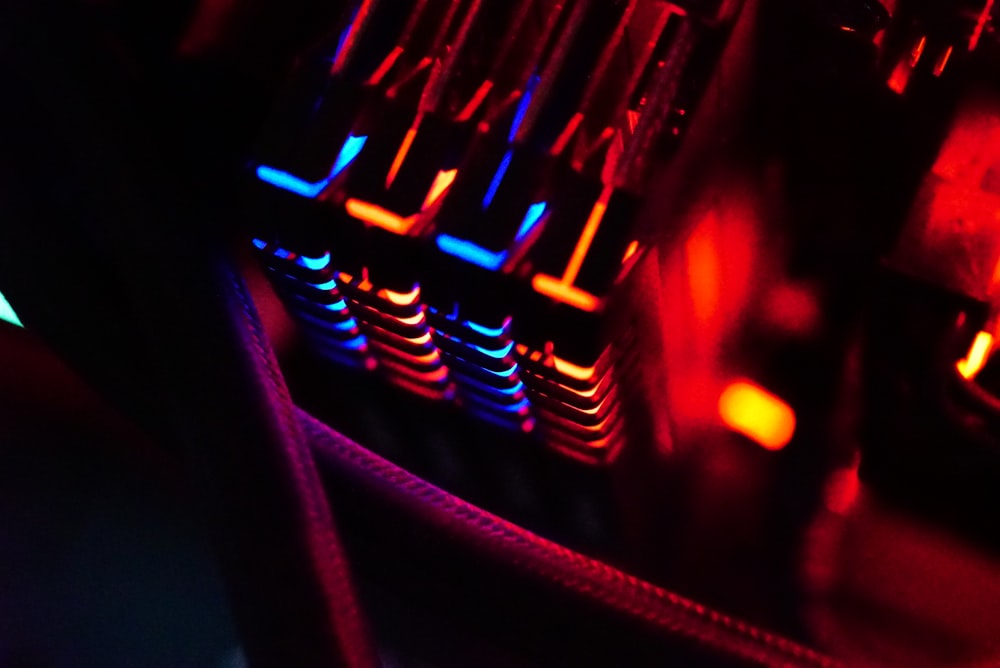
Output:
[719,380,795,450]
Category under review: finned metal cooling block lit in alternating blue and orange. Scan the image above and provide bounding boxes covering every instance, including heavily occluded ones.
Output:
[251,0,738,463]
